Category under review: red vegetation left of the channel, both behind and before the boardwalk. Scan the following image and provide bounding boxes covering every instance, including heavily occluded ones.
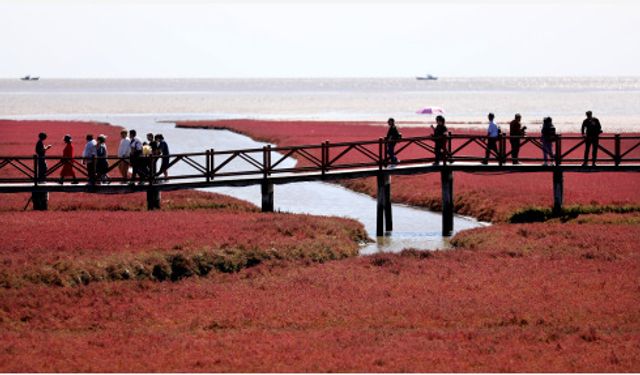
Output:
[0,121,366,286]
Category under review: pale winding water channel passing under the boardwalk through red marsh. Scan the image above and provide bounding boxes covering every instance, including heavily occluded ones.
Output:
[7,114,487,254]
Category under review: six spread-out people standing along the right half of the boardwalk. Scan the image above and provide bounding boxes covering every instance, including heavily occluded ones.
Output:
[386,111,602,167]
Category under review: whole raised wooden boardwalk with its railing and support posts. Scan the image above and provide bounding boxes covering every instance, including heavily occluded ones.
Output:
[0,134,640,235]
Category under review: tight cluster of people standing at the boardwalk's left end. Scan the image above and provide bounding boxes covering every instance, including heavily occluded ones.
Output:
[36,130,169,185]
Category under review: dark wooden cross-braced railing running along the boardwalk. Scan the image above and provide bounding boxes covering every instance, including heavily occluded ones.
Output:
[0,133,640,185]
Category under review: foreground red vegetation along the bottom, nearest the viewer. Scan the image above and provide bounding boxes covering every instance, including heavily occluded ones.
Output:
[0,215,640,372]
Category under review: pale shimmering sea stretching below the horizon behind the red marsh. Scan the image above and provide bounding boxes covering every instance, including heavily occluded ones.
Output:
[0,77,640,132]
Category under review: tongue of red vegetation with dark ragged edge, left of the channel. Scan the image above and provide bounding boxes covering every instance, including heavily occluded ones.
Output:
[0,206,366,287]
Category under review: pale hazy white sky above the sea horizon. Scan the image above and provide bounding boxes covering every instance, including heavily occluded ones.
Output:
[0,0,640,78]
